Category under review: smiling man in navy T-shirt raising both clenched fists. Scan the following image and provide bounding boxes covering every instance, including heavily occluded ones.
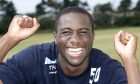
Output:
[0,7,137,84]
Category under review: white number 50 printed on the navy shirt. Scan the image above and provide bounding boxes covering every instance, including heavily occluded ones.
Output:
[89,67,101,84]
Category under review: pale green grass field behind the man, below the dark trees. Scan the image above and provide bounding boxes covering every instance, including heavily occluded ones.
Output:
[1,27,140,62]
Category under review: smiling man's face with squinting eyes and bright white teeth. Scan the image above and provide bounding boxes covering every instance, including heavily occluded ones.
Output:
[55,13,94,66]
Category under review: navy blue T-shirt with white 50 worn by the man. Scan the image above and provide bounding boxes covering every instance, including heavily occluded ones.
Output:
[0,42,127,84]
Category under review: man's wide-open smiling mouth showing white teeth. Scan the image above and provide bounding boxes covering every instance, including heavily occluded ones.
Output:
[67,48,83,56]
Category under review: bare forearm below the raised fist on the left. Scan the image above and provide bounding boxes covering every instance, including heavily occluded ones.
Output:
[0,33,19,63]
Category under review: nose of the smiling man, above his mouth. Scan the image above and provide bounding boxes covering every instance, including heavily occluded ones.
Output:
[70,32,81,46]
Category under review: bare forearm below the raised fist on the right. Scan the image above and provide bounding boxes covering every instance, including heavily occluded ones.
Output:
[123,58,140,84]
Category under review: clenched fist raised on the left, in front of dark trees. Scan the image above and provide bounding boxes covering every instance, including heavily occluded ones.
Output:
[7,15,40,41]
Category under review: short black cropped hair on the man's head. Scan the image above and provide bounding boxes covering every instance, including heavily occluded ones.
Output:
[54,6,94,32]
